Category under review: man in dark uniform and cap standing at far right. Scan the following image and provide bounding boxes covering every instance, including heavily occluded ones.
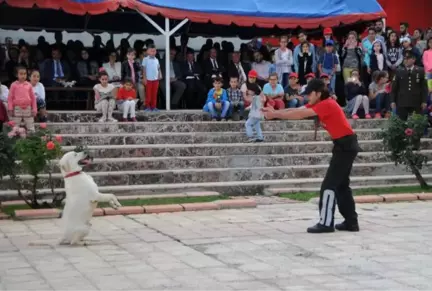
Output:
[390,51,428,120]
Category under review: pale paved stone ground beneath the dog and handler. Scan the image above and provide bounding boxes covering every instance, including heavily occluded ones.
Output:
[0,202,432,291]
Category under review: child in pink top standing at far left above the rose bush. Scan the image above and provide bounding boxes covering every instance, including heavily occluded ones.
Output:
[8,67,37,131]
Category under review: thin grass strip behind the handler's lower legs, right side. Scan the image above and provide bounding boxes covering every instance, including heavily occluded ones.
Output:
[279,186,425,201]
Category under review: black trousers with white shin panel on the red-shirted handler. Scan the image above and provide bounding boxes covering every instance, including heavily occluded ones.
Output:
[319,134,360,227]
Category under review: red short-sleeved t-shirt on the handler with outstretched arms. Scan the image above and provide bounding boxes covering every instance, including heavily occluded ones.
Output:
[306,98,354,139]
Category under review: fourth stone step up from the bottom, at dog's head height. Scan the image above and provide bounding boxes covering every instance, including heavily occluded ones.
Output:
[63,138,432,158]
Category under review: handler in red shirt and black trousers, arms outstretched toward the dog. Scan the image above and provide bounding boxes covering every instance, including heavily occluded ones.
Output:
[264,79,360,233]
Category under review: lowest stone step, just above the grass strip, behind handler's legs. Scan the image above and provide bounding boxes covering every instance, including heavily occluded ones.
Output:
[0,174,432,200]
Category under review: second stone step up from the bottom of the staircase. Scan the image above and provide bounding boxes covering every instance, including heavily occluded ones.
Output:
[4,163,432,190]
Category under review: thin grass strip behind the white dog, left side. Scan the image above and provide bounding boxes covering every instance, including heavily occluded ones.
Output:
[1,195,230,216]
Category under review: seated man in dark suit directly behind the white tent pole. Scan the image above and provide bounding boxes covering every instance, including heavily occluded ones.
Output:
[159,48,186,109]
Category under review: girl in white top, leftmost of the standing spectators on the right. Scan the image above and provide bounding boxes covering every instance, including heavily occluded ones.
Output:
[275,36,294,88]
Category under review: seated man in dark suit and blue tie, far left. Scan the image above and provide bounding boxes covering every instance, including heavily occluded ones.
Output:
[42,47,70,87]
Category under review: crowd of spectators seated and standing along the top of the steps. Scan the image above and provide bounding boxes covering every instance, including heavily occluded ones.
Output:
[0,20,432,124]
